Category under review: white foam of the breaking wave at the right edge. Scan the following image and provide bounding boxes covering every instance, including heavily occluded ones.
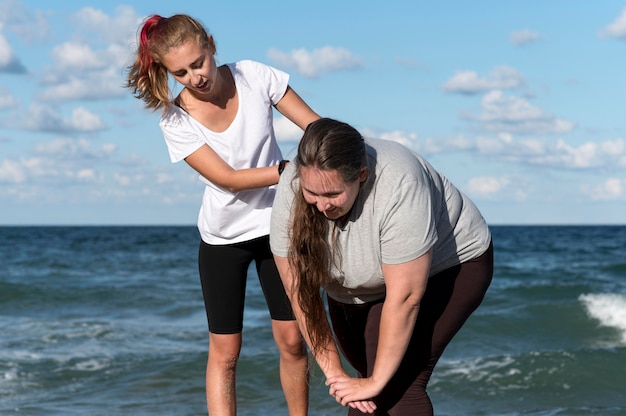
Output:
[578,293,626,343]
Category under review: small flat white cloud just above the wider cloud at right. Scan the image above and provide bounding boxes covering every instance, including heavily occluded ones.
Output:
[443,65,524,94]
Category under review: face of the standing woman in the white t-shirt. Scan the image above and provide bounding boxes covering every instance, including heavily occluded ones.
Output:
[161,40,217,95]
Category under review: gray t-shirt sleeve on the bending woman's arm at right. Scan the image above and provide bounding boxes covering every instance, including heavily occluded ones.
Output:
[379,181,437,264]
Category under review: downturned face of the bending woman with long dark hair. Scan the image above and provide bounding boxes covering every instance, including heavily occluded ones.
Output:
[300,167,367,220]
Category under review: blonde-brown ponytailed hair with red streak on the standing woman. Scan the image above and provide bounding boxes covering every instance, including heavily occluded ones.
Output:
[125,14,215,111]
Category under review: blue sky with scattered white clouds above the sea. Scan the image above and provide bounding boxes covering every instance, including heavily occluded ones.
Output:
[0,0,626,225]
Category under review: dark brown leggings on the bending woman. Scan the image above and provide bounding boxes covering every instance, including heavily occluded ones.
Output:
[328,245,493,416]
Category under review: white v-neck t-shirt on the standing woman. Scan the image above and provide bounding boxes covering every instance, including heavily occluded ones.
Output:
[159,61,289,244]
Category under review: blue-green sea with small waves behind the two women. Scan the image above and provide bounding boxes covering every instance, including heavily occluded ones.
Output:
[0,226,626,416]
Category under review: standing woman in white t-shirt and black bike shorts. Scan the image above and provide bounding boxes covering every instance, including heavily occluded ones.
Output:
[127,14,318,416]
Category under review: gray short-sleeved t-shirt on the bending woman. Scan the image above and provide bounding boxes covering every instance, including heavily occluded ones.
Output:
[270,139,491,303]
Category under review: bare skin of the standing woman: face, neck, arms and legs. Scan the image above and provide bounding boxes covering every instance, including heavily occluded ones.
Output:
[161,38,312,416]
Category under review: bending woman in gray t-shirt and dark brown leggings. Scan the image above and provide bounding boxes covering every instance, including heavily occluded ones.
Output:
[270,119,493,415]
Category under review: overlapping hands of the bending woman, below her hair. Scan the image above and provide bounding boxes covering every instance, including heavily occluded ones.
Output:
[326,375,381,413]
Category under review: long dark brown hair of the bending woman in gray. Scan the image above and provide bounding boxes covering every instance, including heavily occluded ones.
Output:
[289,118,367,351]
